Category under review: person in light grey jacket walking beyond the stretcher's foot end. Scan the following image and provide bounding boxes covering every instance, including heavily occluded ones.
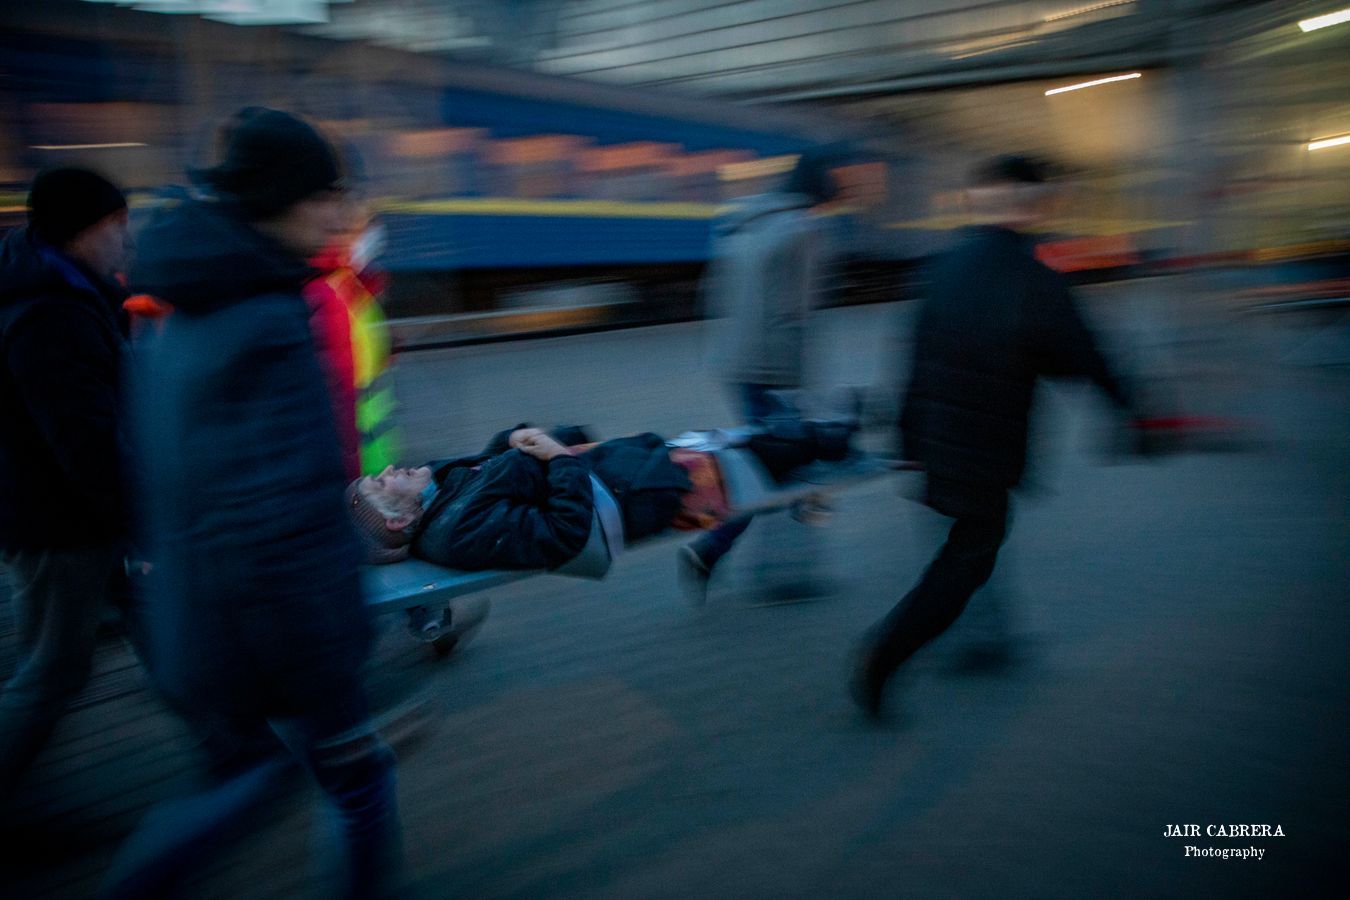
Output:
[678,148,840,603]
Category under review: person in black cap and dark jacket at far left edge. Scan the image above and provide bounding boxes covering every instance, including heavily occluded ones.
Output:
[0,169,128,807]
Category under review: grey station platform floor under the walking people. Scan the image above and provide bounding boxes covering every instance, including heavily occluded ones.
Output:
[0,279,1350,900]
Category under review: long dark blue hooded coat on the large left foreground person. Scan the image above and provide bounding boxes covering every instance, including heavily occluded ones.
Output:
[130,201,370,715]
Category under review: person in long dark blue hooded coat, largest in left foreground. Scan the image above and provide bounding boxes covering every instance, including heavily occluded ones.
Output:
[104,108,400,897]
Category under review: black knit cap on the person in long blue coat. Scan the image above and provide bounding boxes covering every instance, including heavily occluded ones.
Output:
[194,107,344,219]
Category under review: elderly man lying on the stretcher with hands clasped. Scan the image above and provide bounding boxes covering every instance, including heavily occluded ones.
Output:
[347,420,856,580]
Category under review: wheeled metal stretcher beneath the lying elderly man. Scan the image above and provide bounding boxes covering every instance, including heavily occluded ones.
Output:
[363,448,896,645]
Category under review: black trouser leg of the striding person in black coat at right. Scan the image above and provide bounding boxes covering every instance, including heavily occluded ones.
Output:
[868,493,1008,677]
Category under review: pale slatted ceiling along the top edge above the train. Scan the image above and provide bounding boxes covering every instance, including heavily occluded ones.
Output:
[290,0,1337,100]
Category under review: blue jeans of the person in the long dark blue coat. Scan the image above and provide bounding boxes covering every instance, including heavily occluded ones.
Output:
[100,680,402,899]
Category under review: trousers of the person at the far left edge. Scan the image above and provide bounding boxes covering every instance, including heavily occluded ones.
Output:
[0,544,122,806]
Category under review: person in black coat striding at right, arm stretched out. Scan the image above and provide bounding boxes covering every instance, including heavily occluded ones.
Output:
[851,157,1131,715]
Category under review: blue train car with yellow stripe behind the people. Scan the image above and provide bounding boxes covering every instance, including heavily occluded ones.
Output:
[0,0,907,345]
